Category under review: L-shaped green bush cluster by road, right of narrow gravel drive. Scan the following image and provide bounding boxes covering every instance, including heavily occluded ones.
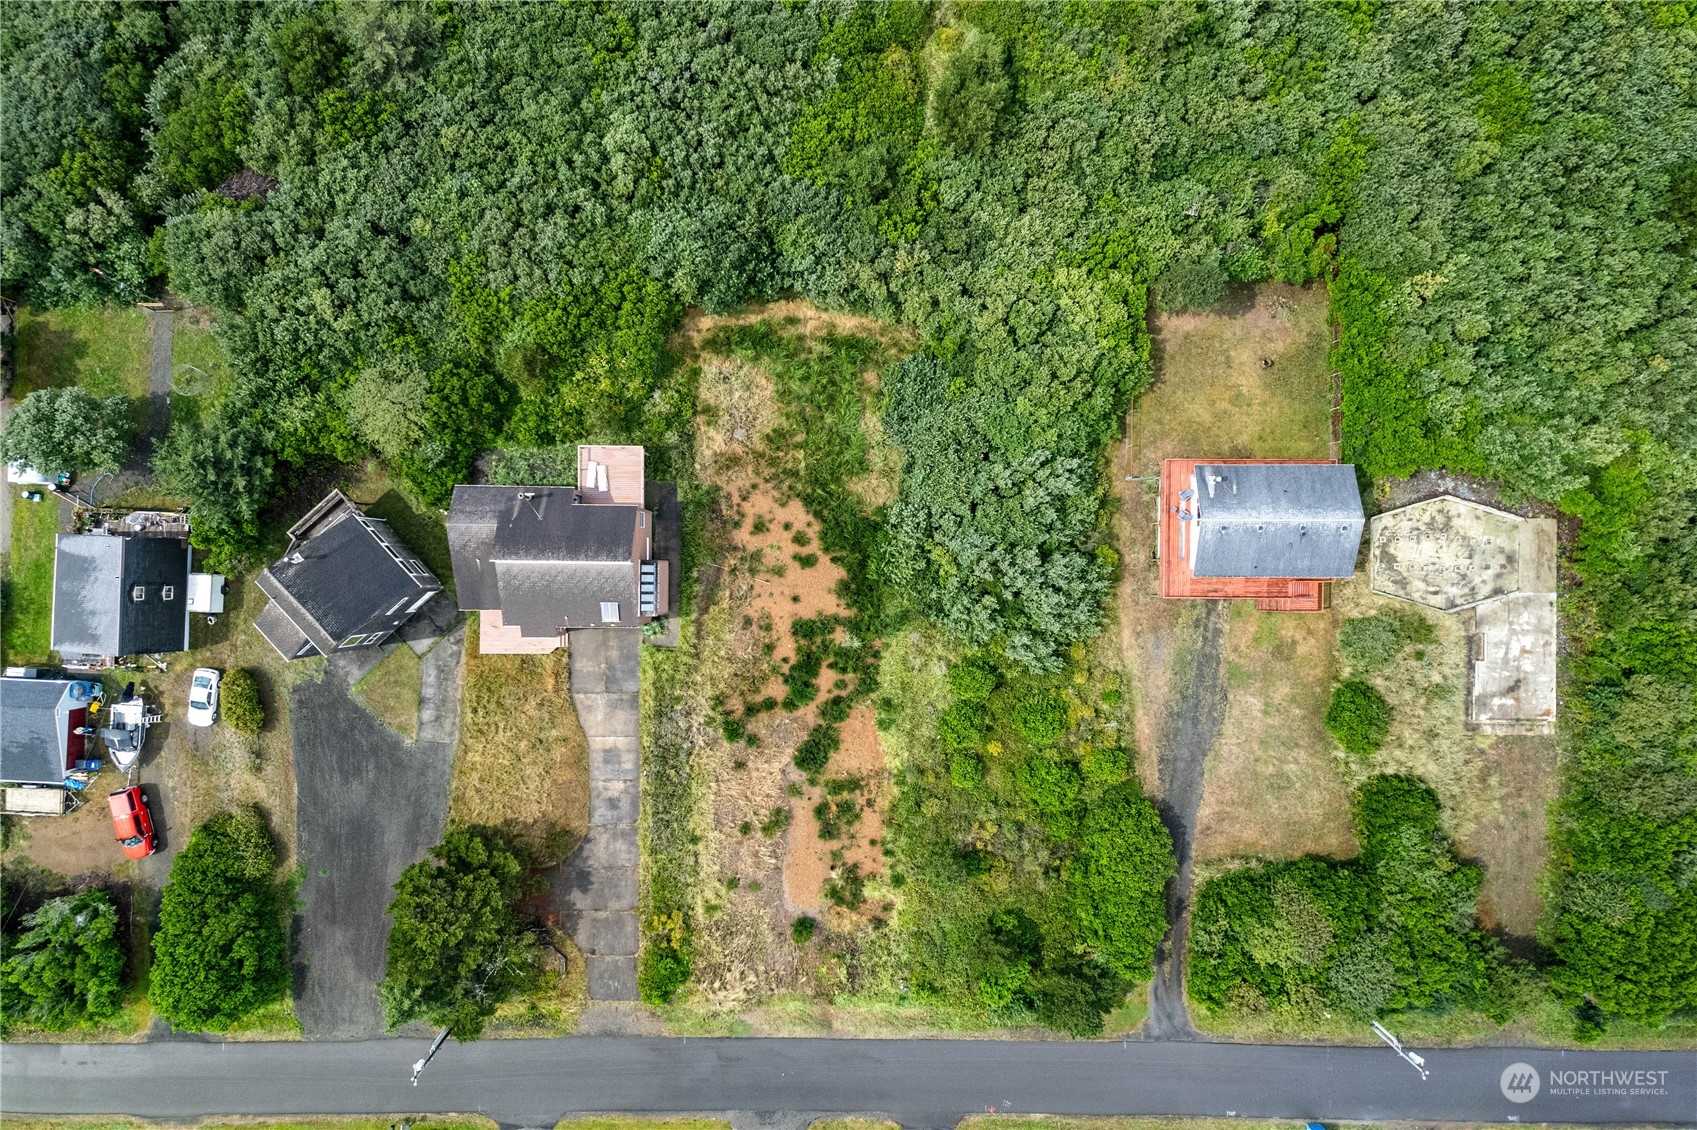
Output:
[1188,777,1536,1023]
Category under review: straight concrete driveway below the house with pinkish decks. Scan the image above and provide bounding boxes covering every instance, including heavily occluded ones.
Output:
[548,628,641,1001]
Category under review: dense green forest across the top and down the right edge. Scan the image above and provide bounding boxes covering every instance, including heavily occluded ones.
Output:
[0,0,1697,1032]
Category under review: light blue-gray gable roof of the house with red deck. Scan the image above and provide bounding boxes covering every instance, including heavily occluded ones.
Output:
[1191,463,1366,579]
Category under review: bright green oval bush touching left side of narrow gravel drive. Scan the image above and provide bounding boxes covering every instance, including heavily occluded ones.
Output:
[1066,780,1178,977]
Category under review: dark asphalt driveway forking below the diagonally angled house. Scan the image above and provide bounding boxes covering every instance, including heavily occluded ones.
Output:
[288,629,465,1040]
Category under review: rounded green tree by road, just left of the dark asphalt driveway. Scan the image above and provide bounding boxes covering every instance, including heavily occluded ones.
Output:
[148,808,288,1030]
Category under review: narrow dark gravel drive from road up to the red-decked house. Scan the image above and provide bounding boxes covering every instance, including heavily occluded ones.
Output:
[1144,601,1229,1040]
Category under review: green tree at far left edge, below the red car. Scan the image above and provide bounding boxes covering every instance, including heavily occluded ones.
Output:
[0,891,124,1032]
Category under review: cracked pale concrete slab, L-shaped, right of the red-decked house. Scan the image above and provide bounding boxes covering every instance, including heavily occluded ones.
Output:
[1368,494,1558,733]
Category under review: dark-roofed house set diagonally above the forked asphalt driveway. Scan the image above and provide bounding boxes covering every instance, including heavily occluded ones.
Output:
[253,490,443,660]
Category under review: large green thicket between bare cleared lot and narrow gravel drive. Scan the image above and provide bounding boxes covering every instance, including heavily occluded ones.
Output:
[884,652,1176,1035]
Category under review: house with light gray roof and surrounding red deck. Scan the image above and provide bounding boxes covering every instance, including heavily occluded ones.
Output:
[1156,460,1366,613]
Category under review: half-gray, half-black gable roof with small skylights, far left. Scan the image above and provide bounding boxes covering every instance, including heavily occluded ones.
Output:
[51,534,190,658]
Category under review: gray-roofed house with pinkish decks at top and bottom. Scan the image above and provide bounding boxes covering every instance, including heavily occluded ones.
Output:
[448,445,675,655]
